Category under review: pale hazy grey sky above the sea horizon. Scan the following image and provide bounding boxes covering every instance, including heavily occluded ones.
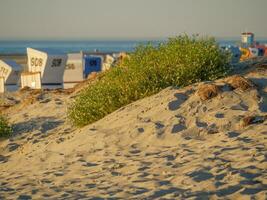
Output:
[0,0,267,40]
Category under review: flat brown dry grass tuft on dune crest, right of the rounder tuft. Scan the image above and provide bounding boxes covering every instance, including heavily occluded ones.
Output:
[226,75,255,91]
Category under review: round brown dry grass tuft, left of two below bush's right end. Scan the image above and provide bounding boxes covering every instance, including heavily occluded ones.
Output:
[197,84,221,101]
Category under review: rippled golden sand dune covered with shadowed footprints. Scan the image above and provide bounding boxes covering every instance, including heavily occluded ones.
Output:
[0,66,267,200]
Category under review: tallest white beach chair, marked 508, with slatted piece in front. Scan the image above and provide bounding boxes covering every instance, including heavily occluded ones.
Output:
[21,48,67,89]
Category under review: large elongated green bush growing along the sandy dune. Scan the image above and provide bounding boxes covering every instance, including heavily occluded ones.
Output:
[68,35,230,126]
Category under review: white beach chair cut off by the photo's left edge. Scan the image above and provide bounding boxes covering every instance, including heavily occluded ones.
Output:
[0,60,21,93]
